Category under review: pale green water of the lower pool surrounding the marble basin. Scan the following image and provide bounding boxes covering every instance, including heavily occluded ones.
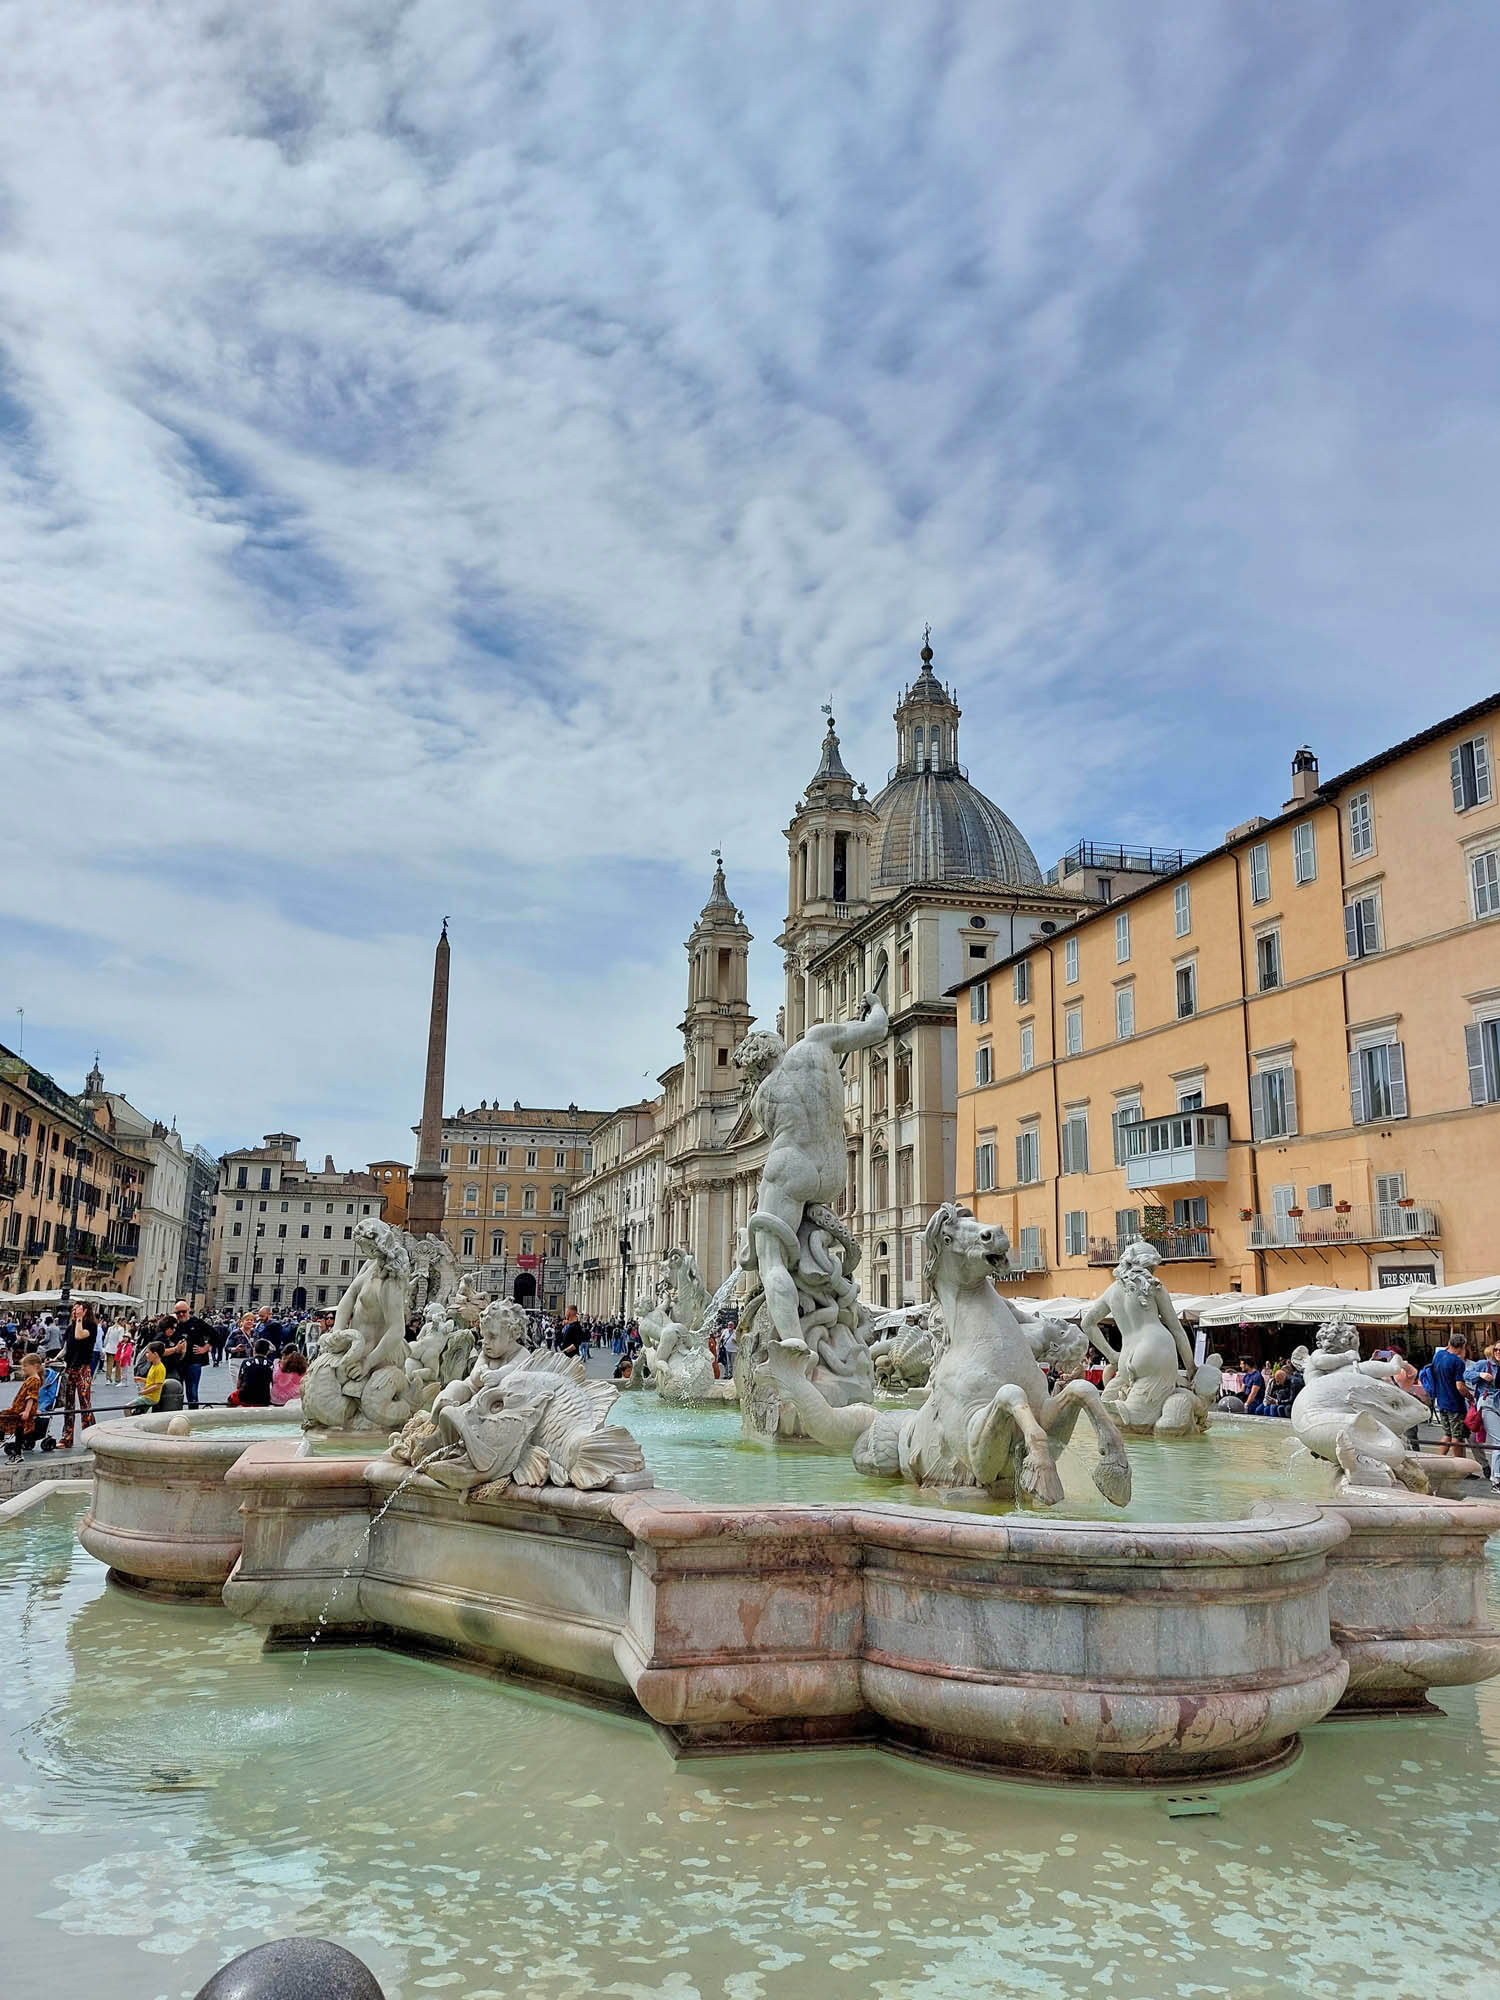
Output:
[0,1502,1500,2000]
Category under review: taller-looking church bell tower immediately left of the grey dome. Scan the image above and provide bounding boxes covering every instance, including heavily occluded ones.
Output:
[776,710,878,1042]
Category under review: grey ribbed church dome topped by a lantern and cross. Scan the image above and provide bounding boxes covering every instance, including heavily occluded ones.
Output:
[874,640,1042,890]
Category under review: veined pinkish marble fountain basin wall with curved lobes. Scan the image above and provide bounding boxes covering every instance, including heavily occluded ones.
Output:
[80,1412,1500,1784]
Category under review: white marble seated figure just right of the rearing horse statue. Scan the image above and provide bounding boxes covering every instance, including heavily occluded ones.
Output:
[1080,1236,1222,1438]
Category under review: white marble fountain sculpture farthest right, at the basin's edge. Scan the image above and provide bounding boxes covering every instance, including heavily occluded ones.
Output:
[1292,1320,1484,1494]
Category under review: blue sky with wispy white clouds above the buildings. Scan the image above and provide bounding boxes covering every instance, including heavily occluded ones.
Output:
[0,0,1500,1164]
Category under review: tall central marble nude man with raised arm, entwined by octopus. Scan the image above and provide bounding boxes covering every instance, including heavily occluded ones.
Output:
[734,994,890,1436]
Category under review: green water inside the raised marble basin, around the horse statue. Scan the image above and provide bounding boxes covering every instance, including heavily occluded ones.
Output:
[614,1394,1332,1520]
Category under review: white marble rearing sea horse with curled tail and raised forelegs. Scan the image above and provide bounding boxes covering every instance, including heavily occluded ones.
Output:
[764,1202,1130,1506]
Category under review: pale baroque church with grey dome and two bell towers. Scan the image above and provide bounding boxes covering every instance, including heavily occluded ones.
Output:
[570,644,1090,1316]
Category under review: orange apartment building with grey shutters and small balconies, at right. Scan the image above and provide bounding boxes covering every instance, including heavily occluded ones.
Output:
[952,694,1500,1298]
